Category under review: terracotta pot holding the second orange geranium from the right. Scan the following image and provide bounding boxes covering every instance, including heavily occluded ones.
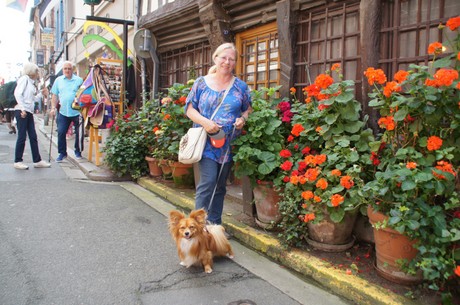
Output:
[307,211,358,252]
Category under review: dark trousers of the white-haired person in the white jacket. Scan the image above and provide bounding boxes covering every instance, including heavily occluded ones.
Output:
[14,110,42,163]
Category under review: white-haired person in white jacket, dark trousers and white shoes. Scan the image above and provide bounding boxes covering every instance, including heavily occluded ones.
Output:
[14,63,51,169]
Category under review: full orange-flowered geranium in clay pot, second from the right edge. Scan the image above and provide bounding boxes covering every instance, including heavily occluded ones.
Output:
[274,64,373,251]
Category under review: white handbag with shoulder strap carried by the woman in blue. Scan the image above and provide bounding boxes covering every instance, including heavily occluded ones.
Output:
[178,77,235,164]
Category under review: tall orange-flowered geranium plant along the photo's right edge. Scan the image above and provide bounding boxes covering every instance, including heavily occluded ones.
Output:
[364,17,460,302]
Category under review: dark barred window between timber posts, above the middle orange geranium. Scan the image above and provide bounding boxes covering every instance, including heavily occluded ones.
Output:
[294,2,361,96]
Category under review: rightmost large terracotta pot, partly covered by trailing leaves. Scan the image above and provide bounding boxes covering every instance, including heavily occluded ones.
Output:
[367,206,422,285]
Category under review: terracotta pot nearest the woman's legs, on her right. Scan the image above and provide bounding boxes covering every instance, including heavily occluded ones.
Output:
[253,181,281,229]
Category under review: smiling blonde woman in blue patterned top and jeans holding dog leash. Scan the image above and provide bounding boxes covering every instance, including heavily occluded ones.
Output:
[185,43,252,224]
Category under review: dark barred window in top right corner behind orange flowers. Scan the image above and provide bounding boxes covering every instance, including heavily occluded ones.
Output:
[379,0,460,75]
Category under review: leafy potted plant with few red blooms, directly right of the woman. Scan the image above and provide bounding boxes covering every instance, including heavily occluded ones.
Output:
[232,87,290,228]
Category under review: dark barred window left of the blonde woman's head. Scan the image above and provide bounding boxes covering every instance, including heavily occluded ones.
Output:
[159,42,212,89]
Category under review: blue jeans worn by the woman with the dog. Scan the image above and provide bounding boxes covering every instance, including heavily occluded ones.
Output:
[195,158,232,224]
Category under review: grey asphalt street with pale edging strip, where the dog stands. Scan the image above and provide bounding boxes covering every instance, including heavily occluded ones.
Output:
[0,119,349,305]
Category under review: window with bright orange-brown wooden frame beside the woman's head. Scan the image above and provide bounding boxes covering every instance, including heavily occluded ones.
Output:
[235,23,280,90]
